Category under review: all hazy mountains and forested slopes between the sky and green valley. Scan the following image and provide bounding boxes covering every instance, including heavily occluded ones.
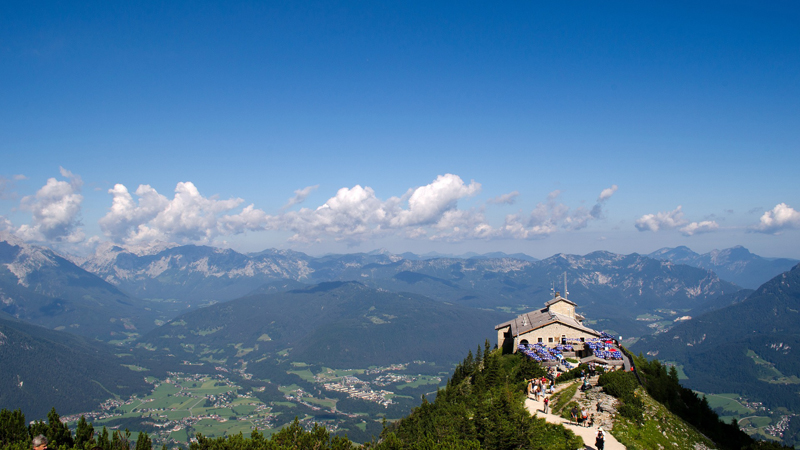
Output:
[0,232,800,440]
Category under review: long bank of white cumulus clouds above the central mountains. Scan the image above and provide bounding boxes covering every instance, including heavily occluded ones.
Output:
[94,174,616,245]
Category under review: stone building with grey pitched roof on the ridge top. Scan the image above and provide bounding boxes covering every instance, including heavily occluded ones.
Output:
[494,292,600,357]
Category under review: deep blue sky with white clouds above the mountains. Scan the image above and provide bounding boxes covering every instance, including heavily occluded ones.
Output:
[0,2,800,258]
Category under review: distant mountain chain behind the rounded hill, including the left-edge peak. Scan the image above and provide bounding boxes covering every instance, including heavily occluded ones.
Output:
[0,236,789,342]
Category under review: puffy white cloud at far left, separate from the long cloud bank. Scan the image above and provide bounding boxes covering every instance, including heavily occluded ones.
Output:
[17,167,84,242]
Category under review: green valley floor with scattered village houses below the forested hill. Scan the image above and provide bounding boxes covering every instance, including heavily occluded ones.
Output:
[61,361,443,446]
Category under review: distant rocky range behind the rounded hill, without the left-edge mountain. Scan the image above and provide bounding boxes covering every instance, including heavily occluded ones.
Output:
[75,246,752,336]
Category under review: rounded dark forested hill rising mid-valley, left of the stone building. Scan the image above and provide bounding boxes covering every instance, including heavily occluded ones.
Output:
[141,282,509,371]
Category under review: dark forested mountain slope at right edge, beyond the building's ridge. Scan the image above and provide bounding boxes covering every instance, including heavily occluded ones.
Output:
[632,265,800,411]
